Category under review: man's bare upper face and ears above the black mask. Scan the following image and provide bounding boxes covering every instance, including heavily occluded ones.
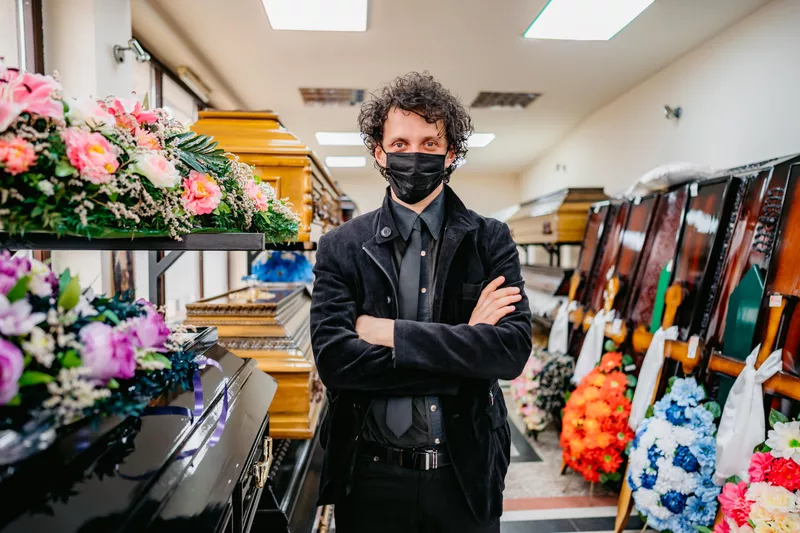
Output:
[375,108,456,167]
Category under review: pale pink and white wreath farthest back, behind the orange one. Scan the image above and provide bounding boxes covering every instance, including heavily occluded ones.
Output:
[511,350,575,433]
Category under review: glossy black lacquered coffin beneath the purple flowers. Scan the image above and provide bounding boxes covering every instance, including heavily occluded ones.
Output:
[0,328,277,533]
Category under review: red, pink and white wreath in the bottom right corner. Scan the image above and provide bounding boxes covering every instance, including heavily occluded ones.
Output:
[701,411,800,533]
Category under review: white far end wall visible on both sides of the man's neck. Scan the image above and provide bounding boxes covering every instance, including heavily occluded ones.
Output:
[333,170,520,216]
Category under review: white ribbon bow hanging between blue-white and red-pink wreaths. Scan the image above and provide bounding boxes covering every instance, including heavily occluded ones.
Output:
[714,345,783,484]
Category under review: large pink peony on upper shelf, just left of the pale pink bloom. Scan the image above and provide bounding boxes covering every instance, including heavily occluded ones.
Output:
[64,128,119,185]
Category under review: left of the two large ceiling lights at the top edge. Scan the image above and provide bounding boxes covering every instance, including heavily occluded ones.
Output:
[261,0,368,31]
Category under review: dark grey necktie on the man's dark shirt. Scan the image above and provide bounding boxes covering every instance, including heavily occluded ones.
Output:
[386,217,423,438]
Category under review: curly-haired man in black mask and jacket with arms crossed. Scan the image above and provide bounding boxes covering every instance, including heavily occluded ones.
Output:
[311,73,531,533]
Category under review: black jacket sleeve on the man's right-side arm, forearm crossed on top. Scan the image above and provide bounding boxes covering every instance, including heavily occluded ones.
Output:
[394,224,532,379]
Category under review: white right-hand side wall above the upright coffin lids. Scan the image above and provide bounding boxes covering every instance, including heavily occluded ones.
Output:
[522,0,800,199]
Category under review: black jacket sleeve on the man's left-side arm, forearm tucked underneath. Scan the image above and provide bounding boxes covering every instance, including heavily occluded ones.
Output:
[311,233,458,396]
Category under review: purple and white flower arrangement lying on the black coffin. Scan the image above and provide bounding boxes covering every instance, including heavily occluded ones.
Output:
[0,251,197,438]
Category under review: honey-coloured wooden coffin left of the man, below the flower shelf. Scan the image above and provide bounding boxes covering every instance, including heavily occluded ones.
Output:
[186,284,323,439]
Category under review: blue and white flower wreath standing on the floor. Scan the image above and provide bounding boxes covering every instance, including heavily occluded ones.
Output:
[628,378,721,533]
